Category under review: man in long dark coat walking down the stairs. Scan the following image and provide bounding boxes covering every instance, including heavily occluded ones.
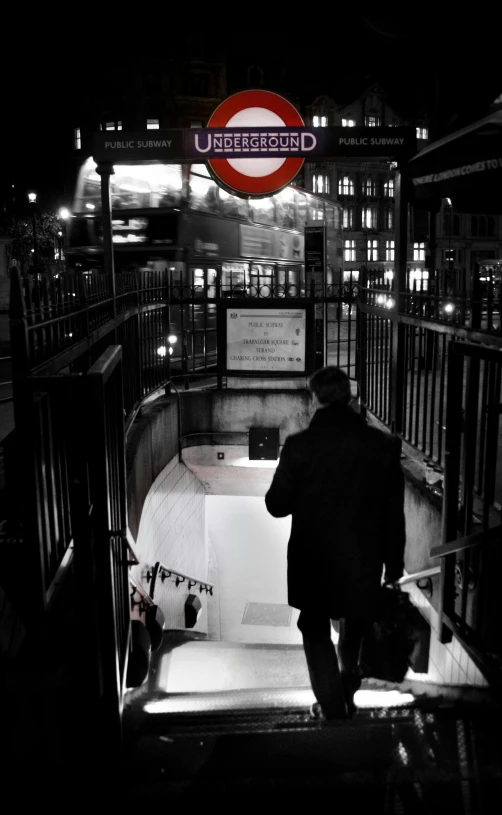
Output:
[265,366,405,719]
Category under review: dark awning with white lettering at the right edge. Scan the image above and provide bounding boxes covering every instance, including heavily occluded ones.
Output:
[408,111,502,213]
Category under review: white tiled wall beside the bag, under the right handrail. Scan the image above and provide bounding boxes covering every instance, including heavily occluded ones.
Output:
[404,583,488,687]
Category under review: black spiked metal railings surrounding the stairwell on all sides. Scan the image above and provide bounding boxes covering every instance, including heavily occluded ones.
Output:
[10,261,502,712]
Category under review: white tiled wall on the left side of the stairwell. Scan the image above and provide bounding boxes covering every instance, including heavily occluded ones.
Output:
[132,457,209,633]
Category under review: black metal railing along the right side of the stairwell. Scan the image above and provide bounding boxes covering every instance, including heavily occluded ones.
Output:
[358,267,502,679]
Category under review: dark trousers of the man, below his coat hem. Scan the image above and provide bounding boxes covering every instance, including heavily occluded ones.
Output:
[298,609,367,718]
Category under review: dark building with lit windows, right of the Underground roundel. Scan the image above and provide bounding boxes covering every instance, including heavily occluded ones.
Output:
[304,85,502,289]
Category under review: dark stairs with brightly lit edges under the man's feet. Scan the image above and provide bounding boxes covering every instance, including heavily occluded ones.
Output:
[117,642,502,815]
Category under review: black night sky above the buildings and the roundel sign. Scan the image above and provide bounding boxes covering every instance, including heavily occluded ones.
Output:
[0,10,502,207]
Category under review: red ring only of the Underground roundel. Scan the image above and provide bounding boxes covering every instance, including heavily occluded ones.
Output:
[207,91,304,195]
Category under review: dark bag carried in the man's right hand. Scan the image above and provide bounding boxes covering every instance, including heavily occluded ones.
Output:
[359,585,430,682]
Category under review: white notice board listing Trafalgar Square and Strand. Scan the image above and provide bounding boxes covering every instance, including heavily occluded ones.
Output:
[226,306,306,373]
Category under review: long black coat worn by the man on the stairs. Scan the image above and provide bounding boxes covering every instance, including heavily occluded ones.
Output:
[265,406,405,619]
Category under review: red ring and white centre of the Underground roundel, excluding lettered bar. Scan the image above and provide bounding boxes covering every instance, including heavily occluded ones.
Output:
[207,90,304,198]
